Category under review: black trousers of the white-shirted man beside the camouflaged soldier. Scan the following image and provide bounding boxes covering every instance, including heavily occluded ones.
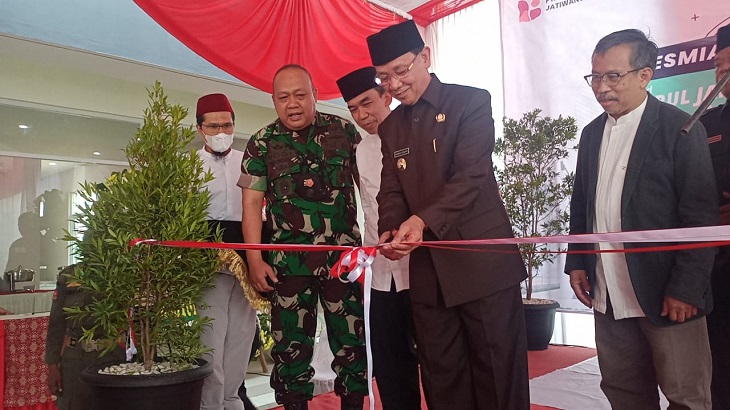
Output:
[370,284,421,410]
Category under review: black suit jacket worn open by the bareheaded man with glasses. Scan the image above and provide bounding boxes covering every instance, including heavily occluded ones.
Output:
[565,94,718,325]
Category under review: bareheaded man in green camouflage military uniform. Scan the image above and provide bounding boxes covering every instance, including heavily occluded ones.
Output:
[239,65,367,410]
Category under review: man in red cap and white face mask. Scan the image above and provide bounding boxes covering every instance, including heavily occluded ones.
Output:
[196,94,256,410]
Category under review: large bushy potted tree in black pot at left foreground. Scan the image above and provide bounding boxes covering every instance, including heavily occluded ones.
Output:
[67,82,218,409]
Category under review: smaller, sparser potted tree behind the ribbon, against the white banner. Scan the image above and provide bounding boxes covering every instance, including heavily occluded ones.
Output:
[494,109,578,350]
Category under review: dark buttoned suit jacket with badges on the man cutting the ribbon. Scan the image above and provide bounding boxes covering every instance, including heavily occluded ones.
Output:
[377,75,526,306]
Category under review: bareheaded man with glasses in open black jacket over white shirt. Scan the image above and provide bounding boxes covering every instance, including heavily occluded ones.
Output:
[565,30,718,409]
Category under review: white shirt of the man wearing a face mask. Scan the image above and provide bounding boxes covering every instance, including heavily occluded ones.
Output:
[198,148,243,221]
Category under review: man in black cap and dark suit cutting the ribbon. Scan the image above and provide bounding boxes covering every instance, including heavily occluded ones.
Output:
[367,21,530,410]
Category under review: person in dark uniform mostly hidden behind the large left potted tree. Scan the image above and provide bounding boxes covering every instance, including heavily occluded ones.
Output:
[45,265,124,410]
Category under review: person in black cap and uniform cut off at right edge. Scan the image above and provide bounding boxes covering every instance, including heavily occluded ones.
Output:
[700,25,730,409]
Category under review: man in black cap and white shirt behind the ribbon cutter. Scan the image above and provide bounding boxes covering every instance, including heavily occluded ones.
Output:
[337,67,421,410]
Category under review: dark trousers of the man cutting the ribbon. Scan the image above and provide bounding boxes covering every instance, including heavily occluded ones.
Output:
[413,284,530,410]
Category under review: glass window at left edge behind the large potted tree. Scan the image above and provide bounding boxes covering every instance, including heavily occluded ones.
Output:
[0,156,123,313]
